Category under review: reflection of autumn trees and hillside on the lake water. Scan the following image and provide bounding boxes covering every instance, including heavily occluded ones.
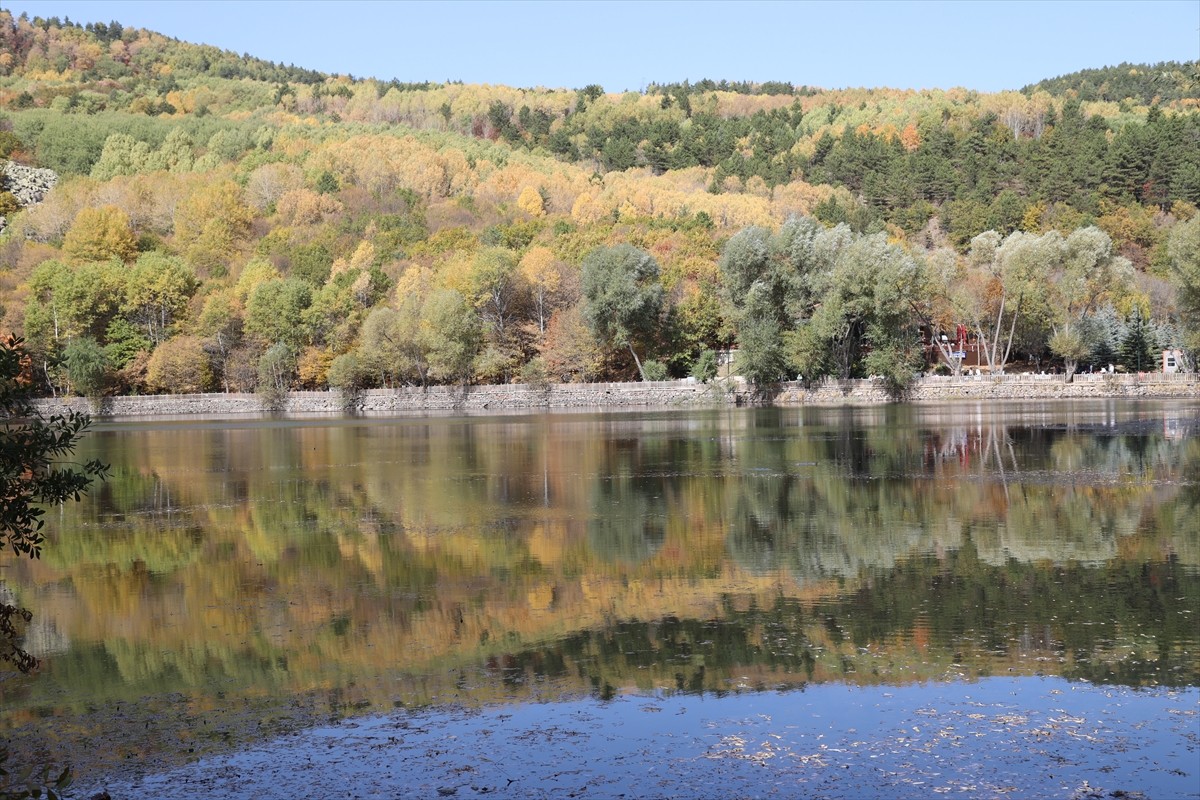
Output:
[0,402,1200,782]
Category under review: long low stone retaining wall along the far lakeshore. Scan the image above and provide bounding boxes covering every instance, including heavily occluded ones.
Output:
[30,373,1200,419]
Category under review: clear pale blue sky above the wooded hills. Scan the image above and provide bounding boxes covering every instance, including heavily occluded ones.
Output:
[0,0,1200,92]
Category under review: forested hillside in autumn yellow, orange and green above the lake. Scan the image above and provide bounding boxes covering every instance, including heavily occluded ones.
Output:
[0,11,1200,395]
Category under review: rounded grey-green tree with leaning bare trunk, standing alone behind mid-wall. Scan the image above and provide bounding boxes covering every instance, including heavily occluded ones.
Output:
[582,245,664,380]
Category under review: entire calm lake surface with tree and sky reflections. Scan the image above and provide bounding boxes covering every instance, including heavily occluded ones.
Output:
[0,399,1200,799]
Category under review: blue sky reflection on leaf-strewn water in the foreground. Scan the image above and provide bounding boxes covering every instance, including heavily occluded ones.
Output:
[87,678,1200,799]
